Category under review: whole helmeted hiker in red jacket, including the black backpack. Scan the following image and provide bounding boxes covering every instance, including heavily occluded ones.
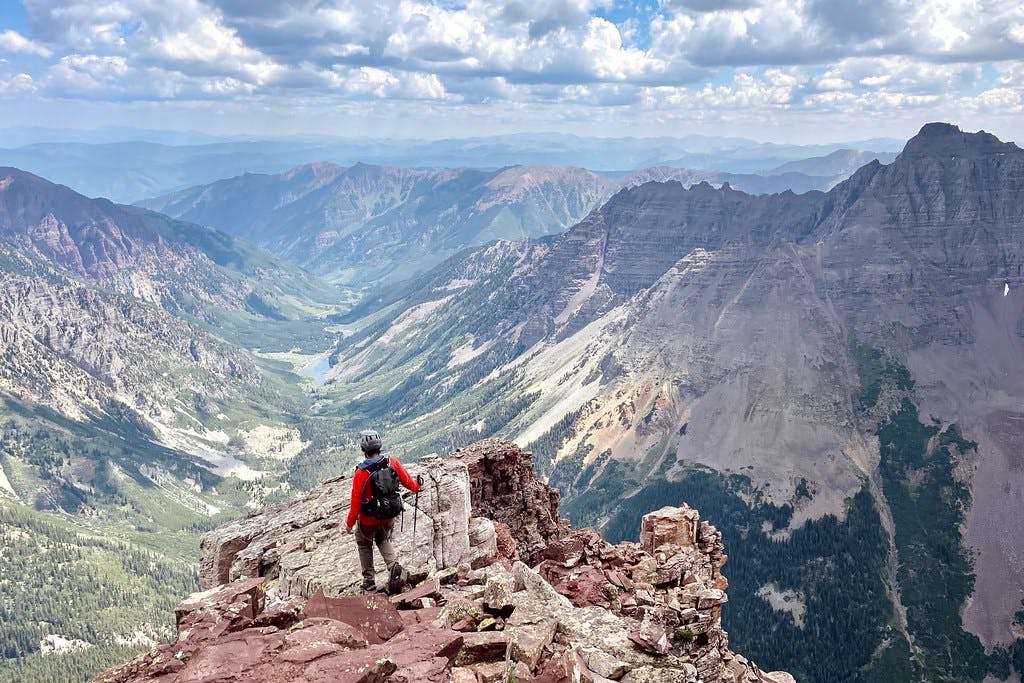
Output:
[346,430,422,593]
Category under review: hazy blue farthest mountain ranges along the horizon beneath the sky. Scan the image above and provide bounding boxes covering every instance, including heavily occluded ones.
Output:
[0,130,898,202]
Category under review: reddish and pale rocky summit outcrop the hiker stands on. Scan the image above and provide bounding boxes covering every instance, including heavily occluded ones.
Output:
[94,439,794,683]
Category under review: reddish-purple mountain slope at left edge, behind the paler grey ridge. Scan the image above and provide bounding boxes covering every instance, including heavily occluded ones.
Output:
[0,168,323,319]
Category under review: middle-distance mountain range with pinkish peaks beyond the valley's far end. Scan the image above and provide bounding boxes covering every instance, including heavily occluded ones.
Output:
[139,150,892,289]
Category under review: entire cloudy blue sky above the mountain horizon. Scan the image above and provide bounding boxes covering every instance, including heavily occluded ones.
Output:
[0,0,1024,142]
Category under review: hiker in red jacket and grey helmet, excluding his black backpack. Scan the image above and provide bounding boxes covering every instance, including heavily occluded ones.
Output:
[345,431,420,593]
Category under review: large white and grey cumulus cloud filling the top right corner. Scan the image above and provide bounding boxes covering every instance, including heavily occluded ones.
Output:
[652,0,1024,66]
